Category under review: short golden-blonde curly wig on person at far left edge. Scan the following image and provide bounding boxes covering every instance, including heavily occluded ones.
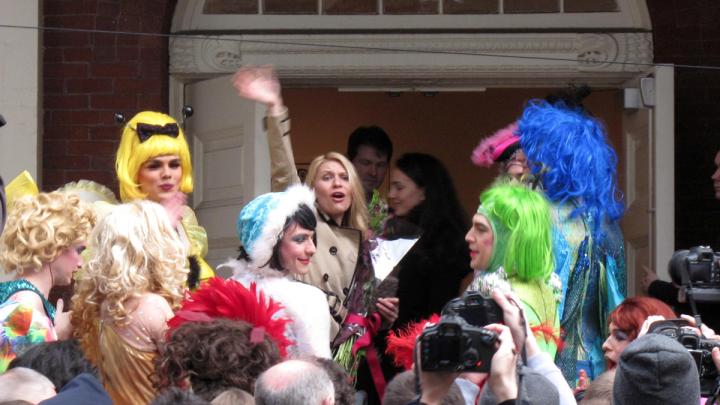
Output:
[0,192,95,275]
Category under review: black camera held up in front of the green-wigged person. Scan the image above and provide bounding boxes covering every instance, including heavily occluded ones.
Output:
[420,315,498,373]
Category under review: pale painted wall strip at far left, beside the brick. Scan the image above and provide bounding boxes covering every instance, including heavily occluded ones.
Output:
[0,0,42,183]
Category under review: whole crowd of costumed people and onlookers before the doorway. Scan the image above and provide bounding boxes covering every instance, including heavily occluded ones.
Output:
[0,67,720,405]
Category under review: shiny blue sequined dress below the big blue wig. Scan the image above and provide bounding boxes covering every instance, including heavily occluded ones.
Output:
[552,202,627,386]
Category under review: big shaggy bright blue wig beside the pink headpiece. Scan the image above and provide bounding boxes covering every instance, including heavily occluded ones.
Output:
[518,100,624,237]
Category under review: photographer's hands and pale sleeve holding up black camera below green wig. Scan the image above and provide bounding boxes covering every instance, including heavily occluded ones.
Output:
[416,290,572,404]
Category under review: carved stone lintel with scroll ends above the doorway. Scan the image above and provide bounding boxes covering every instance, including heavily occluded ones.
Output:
[170,33,653,86]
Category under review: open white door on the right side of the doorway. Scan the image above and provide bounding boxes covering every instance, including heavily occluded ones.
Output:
[620,66,675,296]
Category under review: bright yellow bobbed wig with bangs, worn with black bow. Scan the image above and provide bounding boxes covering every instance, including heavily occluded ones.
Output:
[115,111,193,202]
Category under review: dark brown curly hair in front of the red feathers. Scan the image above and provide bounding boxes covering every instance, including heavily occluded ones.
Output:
[155,319,281,401]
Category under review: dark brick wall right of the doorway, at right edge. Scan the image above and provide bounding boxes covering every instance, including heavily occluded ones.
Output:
[647,0,720,250]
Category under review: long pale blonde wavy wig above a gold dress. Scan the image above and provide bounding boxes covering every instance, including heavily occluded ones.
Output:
[72,200,188,352]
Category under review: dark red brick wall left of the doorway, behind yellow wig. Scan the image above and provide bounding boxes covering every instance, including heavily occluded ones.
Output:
[42,0,176,191]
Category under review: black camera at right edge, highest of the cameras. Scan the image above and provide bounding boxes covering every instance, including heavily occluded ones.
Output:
[668,246,720,302]
